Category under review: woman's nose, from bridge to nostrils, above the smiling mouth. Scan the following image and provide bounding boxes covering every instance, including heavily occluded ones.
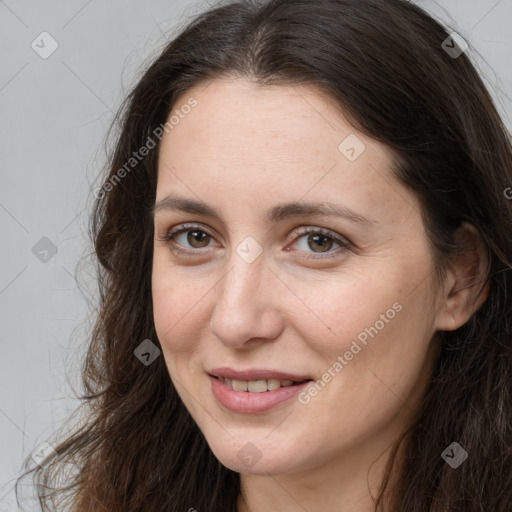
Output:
[210,246,283,348]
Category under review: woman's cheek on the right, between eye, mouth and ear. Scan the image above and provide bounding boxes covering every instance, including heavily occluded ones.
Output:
[295,268,433,398]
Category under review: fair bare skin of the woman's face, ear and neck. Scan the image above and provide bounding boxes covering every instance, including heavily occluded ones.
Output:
[152,78,486,512]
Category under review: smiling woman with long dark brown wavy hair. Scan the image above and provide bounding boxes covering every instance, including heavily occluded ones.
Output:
[16,0,512,512]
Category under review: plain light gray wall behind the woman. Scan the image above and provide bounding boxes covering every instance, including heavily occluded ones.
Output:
[0,0,512,512]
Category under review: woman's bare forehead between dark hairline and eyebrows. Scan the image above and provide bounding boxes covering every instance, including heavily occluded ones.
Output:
[157,78,416,226]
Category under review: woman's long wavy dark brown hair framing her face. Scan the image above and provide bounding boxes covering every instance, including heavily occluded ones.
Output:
[16,0,512,512]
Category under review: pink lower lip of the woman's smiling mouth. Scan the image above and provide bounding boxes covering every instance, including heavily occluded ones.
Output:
[209,375,311,414]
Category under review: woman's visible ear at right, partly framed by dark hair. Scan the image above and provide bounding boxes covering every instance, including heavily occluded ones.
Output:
[436,222,490,331]
